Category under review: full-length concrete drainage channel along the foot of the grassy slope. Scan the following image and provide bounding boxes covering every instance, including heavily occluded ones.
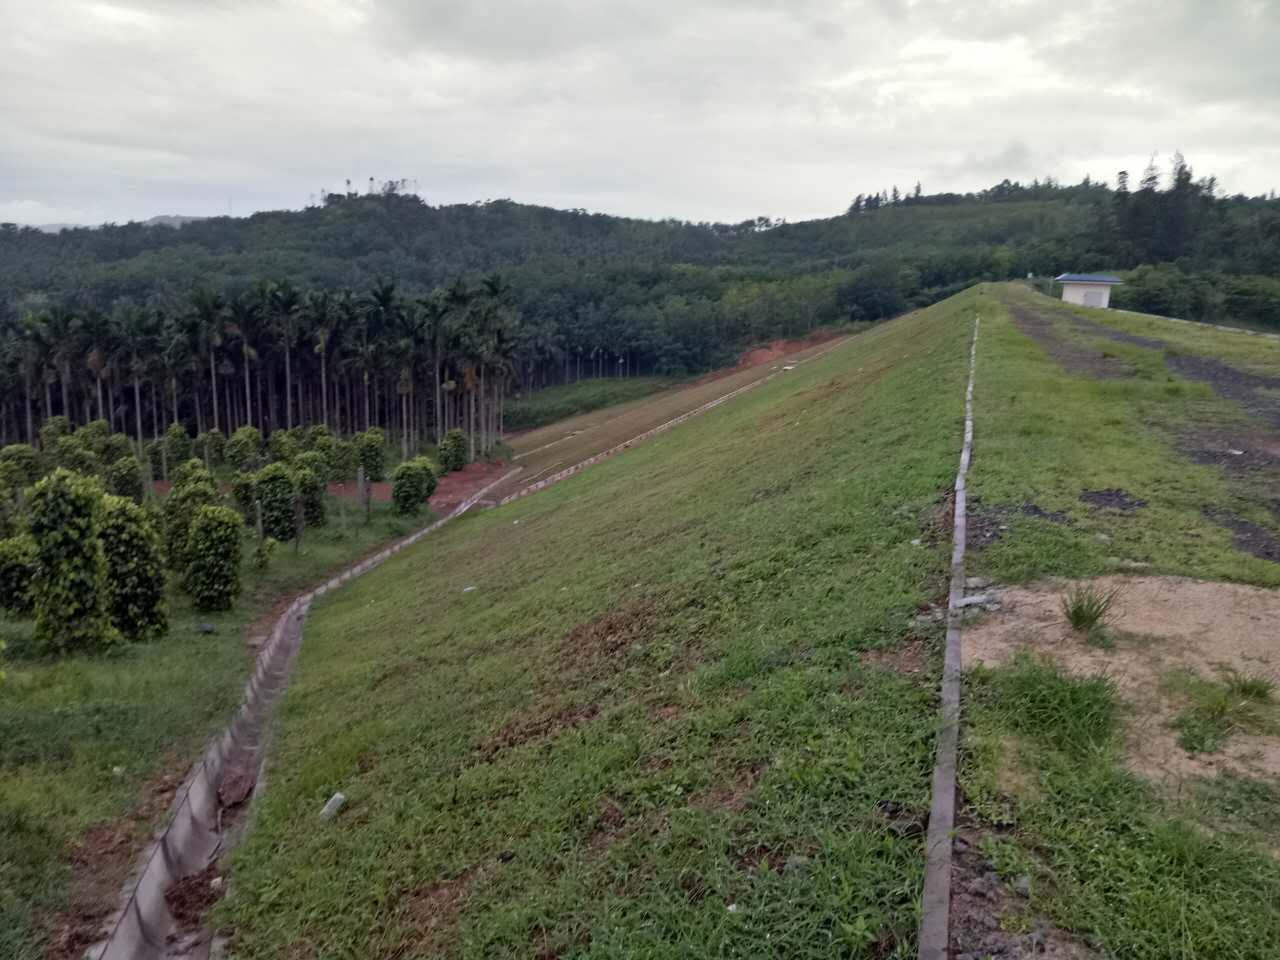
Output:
[84,338,849,960]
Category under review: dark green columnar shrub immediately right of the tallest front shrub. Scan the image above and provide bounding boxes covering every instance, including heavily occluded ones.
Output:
[101,496,169,641]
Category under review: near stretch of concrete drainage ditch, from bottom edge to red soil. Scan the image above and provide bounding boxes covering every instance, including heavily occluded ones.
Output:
[88,467,520,960]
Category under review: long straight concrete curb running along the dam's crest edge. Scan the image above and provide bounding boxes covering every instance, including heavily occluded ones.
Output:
[920,316,982,960]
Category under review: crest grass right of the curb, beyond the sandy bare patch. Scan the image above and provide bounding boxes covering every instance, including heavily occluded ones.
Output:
[969,284,1280,586]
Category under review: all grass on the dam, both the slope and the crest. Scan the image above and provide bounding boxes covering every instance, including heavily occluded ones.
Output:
[214,287,1280,959]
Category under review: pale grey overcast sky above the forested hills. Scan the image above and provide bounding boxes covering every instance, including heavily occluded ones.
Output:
[0,0,1280,224]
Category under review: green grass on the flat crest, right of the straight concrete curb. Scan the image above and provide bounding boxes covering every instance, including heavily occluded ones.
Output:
[961,281,1280,960]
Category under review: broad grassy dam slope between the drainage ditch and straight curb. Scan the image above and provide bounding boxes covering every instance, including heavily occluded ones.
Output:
[216,294,993,957]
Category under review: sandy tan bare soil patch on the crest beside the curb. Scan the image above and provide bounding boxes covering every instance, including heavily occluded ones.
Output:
[963,576,1280,787]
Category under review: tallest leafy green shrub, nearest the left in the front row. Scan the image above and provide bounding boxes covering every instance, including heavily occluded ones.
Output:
[31,468,120,654]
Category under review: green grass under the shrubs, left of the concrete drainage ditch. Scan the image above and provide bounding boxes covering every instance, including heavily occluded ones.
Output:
[0,499,425,960]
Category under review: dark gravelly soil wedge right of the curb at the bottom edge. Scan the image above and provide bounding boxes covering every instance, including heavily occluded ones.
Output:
[950,824,1097,960]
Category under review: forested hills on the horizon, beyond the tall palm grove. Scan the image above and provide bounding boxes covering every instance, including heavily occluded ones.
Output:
[0,172,1280,333]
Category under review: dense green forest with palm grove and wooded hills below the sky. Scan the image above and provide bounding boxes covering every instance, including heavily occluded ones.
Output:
[0,157,1280,440]
